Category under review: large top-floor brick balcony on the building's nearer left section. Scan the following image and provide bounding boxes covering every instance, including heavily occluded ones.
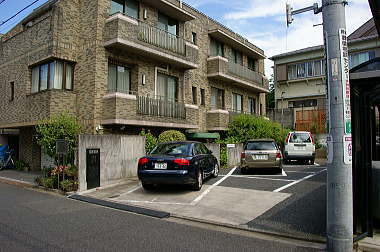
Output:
[105,13,199,69]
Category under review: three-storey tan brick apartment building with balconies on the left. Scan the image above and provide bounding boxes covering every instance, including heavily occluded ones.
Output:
[0,0,268,169]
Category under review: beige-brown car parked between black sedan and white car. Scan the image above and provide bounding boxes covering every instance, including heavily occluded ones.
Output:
[240,139,282,173]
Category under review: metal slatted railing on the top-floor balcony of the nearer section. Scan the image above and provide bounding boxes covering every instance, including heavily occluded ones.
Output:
[138,21,185,55]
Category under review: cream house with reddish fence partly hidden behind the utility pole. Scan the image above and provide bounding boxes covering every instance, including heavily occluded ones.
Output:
[270,19,380,133]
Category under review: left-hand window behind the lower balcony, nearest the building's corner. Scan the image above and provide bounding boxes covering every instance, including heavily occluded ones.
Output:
[108,63,131,94]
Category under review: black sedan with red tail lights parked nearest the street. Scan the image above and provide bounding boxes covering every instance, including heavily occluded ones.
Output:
[138,141,219,190]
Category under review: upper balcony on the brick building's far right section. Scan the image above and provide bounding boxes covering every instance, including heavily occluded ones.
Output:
[207,56,269,93]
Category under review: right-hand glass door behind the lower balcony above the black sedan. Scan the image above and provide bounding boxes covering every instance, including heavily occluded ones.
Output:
[156,73,178,101]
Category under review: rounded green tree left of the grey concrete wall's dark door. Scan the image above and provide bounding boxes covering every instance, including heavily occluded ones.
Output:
[36,112,82,162]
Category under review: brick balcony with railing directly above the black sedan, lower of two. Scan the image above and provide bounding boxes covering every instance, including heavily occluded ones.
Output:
[102,92,198,129]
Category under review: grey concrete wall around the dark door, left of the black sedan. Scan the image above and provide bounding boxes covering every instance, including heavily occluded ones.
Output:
[78,135,145,191]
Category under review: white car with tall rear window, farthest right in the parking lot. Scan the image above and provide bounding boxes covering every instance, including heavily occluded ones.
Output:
[284,131,315,164]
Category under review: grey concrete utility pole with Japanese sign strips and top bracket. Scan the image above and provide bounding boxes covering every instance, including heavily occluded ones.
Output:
[286,0,353,252]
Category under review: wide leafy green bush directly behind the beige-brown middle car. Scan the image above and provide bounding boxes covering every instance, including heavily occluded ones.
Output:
[225,114,290,145]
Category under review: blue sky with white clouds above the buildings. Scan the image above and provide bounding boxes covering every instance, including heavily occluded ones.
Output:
[0,0,372,77]
